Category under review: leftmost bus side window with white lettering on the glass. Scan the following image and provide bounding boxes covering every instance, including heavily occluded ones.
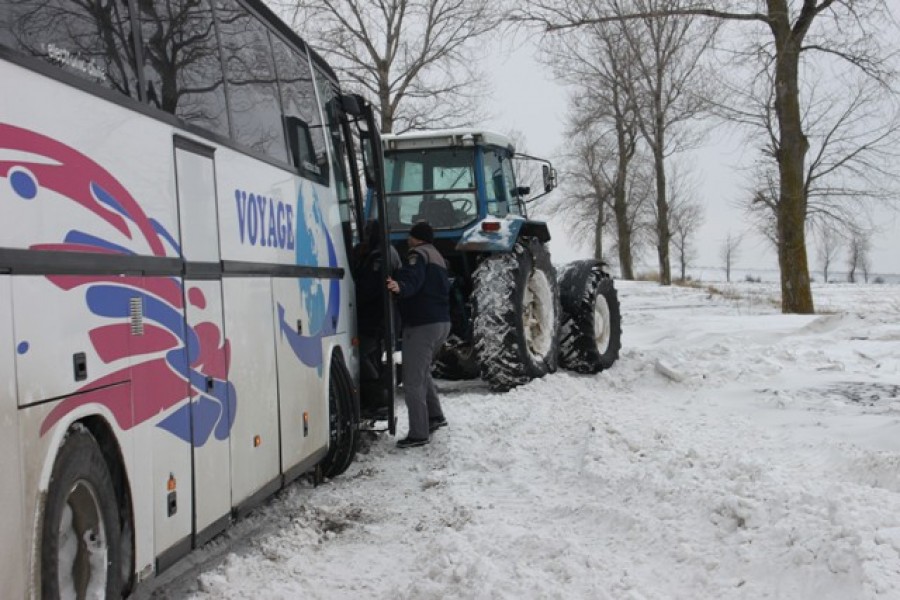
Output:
[0,0,138,99]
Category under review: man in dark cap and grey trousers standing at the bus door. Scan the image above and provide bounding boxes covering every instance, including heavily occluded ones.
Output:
[387,221,450,448]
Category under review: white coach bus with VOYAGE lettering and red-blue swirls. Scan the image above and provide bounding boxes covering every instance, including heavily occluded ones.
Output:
[0,0,393,598]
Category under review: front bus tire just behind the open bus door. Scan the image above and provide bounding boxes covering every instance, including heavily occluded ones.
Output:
[319,357,359,479]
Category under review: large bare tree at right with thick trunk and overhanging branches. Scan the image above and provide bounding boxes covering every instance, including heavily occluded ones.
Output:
[512,0,890,313]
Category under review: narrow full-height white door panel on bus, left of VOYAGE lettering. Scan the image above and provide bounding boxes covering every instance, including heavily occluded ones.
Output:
[175,137,235,547]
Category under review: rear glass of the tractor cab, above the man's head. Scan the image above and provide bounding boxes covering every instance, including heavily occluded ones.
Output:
[384,148,478,231]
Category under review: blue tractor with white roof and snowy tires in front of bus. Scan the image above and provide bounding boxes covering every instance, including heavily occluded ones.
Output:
[372,129,622,391]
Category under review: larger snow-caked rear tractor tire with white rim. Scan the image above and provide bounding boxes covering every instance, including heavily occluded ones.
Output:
[473,240,559,391]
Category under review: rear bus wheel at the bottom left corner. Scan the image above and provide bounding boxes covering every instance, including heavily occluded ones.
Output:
[41,429,122,598]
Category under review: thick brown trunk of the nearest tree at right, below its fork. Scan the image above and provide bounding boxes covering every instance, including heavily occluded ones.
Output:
[775,39,815,314]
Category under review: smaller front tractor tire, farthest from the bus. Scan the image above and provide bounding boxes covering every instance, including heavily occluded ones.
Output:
[559,260,622,373]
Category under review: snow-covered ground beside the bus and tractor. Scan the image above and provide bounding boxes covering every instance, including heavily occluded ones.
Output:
[142,281,900,600]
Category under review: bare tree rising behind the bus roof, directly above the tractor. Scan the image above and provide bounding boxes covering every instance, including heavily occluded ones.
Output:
[279,0,498,133]
